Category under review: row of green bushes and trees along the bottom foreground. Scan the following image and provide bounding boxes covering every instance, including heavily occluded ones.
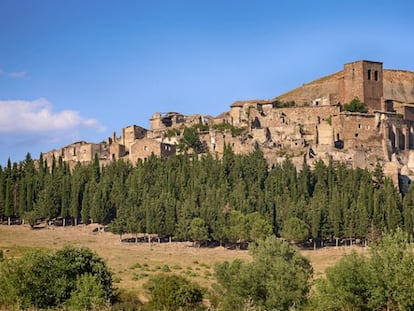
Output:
[0,230,414,311]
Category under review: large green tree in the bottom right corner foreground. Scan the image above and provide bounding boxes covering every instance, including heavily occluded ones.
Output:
[311,229,414,311]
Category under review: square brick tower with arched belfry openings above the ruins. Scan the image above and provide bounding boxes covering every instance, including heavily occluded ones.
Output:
[339,60,383,110]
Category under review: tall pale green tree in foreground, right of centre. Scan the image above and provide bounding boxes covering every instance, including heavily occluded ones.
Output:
[215,236,312,310]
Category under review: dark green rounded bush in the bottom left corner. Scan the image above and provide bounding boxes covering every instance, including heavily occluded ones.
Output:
[0,247,113,309]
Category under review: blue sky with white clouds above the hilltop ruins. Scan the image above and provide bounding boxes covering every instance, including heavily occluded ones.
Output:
[0,0,414,166]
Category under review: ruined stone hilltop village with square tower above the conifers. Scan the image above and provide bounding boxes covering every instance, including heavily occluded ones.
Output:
[42,60,414,187]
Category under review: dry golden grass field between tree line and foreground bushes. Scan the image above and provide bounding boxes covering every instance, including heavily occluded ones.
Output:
[0,225,365,301]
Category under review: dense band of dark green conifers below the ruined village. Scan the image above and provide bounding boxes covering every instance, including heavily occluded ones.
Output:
[0,147,414,245]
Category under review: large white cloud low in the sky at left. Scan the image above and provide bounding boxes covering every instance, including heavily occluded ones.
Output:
[0,98,104,134]
